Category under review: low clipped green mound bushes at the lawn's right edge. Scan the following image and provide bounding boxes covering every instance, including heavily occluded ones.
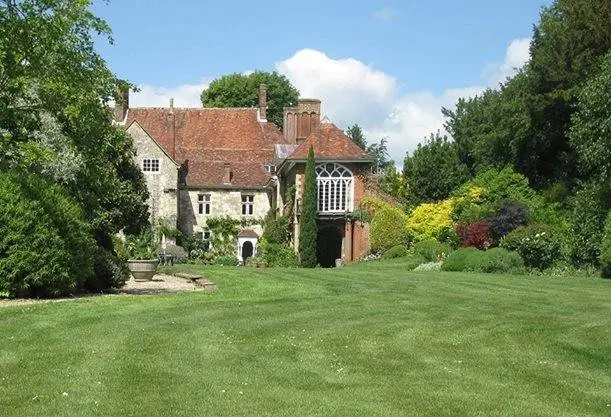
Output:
[441,248,524,273]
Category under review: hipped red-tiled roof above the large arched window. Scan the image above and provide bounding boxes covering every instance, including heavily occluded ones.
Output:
[288,122,371,162]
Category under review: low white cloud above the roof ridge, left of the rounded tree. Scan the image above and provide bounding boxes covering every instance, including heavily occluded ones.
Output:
[129,80,210,107]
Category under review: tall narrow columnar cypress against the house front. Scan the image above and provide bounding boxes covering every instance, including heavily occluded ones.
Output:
[299,146,318,268]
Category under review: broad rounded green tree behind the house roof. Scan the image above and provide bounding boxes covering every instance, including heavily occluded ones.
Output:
[201,71,299,128]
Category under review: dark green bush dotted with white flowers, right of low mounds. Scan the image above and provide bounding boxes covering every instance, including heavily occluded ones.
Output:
[500,224,564,270]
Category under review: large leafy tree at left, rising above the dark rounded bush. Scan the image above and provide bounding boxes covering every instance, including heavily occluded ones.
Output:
[0,0,148,242]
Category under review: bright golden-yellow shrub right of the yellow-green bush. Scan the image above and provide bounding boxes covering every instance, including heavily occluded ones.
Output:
[407,198,455,240]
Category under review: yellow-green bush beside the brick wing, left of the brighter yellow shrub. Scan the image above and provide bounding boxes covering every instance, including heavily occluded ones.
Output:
[362,198,412,253]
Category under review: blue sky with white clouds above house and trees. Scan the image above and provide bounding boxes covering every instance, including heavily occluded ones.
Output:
[94,0,550,165]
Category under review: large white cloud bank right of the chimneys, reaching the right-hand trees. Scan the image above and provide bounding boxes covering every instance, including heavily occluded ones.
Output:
[276,39,530,165]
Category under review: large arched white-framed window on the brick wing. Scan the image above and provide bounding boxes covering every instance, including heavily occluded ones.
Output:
[316,163,354,213]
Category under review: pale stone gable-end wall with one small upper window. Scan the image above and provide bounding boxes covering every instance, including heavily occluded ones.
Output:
[127,123,178,227]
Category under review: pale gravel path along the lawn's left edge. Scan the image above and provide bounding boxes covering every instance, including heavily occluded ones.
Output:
[0,275,216,307]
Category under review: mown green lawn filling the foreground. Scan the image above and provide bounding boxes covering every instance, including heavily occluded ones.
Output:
[0,258,611,417]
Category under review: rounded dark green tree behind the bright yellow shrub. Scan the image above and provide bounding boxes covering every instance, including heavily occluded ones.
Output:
[403,132,469,204]
